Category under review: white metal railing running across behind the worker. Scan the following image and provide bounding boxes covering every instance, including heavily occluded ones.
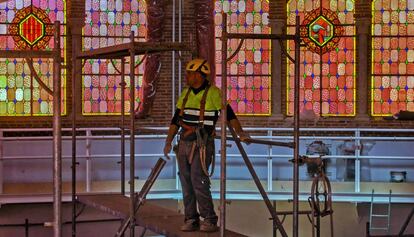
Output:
[0,127,414,203]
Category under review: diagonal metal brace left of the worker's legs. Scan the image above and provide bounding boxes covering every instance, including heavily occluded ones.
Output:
[115,158,167,237]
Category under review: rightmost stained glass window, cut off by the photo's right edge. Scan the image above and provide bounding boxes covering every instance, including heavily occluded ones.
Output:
[371,0,414,116]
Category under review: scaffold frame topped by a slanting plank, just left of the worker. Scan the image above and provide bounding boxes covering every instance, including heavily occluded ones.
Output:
[72,31,197,236]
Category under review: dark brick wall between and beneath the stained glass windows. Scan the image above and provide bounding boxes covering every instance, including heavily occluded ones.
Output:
[0,0,414,128]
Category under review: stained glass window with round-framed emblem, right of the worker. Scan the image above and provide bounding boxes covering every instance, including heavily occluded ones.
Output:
[287,0,355,116]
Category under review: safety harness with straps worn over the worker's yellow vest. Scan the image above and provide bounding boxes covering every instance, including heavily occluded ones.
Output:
[179,85,216,177]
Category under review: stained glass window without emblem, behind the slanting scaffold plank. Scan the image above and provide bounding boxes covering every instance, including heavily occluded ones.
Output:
[82,0,146,115]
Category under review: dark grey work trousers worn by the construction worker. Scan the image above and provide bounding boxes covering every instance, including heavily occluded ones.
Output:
[177,139,218,224]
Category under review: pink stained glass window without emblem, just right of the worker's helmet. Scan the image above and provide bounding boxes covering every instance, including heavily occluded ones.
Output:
[215,0,271,115]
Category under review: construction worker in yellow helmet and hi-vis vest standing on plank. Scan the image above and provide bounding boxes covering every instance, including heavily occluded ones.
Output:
[164,58,249,232]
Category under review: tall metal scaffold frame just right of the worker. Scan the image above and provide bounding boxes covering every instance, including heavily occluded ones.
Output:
[220,14,301,237]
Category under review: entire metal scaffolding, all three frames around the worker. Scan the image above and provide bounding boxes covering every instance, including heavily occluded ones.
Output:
[0,7,301,237]
